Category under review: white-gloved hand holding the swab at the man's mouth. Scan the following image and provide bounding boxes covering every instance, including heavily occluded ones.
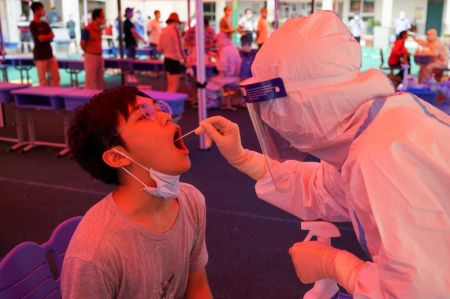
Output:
[200,116,268,180]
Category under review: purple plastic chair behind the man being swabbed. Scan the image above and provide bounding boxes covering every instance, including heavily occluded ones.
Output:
[0,216,81,299]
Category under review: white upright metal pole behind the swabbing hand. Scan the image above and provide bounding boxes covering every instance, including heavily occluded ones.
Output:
[195,0,208,150]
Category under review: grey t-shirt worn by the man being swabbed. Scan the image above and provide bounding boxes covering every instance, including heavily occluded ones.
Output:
[61,183,208,299]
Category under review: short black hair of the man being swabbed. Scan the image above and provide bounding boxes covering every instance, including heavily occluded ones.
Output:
[69,86,150,185]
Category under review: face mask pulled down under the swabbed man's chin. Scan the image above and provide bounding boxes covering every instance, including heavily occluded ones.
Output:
[113,149,180,199]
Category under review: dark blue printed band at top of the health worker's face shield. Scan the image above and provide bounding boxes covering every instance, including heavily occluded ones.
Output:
[241,78,287,103]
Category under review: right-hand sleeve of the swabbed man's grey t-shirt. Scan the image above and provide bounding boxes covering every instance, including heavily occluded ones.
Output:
[189,188,208,272]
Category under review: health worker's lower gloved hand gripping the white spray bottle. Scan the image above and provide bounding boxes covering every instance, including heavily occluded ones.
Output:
[289,241,364,294]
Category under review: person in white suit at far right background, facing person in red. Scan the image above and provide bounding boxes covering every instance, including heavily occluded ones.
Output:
[413,28,448,83]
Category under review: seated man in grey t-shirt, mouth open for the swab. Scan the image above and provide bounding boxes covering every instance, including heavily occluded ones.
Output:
[61,87,212,298]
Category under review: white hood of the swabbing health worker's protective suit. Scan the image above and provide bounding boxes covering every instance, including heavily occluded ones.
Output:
[241,11,394,164]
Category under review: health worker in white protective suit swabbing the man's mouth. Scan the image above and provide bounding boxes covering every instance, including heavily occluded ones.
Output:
[201,11,450,299]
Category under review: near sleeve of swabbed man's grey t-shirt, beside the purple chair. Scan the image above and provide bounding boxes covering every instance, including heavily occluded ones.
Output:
[61,258,115,299]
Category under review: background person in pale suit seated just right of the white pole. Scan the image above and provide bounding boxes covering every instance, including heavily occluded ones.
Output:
[206,32,242,108]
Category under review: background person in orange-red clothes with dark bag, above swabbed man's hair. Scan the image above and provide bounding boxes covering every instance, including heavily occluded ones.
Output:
[80,8,105,89]
